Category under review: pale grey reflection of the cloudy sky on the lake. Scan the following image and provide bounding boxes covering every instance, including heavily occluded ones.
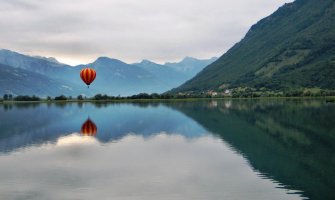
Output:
[0,133,301,200]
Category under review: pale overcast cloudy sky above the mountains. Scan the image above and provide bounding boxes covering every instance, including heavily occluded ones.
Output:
[0,0,293,65]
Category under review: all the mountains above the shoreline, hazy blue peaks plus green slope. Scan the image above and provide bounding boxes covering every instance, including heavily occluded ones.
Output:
[0,0,335,96]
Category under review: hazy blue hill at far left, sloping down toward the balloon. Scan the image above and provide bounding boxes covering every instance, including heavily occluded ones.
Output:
[0,49,97,96]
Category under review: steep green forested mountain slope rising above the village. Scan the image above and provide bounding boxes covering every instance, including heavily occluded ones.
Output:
[172,0,335,92]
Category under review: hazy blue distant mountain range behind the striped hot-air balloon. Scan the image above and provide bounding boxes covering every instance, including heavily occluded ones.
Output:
[0,49,215,96]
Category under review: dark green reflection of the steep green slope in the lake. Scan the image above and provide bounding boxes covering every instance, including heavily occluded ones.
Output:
[170,100,335,200]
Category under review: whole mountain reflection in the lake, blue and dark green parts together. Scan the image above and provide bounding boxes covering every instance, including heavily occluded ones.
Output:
[0,100,335,200]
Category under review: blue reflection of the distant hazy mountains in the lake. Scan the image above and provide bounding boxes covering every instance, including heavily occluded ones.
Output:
[0,103,205,152]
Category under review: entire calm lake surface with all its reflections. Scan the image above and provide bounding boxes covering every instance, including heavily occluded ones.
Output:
[0,99,335,200]
